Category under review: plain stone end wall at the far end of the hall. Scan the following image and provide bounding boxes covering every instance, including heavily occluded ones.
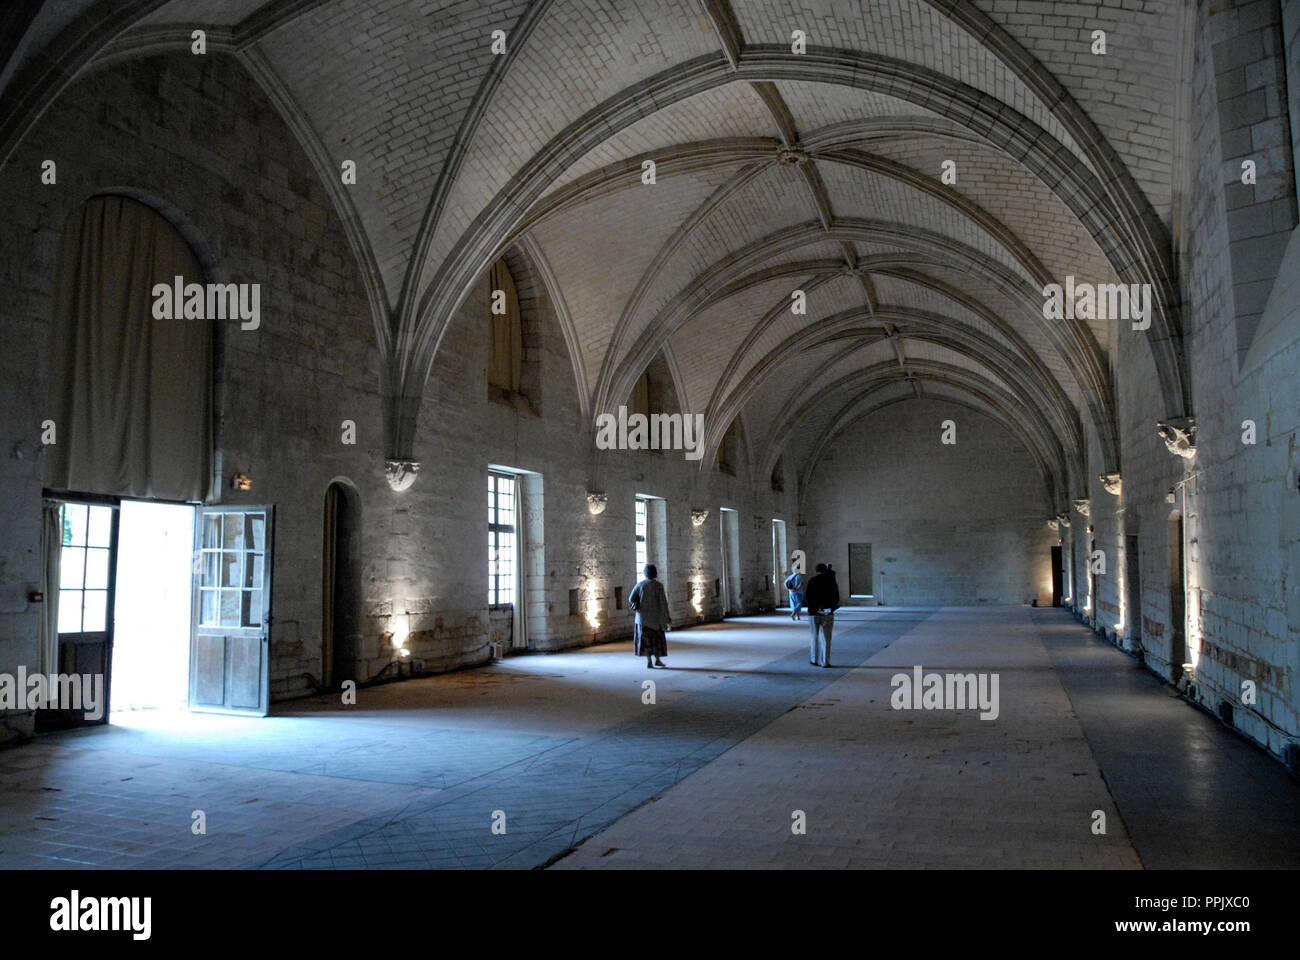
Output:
[803,399,1057,605]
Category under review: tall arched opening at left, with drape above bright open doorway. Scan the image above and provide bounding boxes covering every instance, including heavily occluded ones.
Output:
[38,194,213,726]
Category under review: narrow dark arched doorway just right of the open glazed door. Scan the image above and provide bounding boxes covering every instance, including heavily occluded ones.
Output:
[321,480,361,688]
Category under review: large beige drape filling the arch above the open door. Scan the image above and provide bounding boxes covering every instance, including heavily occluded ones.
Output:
[46,196,212,501]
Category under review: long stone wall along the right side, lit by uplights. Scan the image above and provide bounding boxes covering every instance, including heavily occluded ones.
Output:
[1071,3,1300,756]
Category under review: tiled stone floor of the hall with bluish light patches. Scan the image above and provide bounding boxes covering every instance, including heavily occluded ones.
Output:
[0,607,1300,869]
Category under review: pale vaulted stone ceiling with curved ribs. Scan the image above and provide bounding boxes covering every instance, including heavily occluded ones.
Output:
[0,0,1188,502]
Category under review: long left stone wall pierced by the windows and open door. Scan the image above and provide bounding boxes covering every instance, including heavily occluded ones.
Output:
[0,53,797,739]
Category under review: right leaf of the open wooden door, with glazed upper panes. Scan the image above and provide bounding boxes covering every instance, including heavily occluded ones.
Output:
[190,505,274,717]
